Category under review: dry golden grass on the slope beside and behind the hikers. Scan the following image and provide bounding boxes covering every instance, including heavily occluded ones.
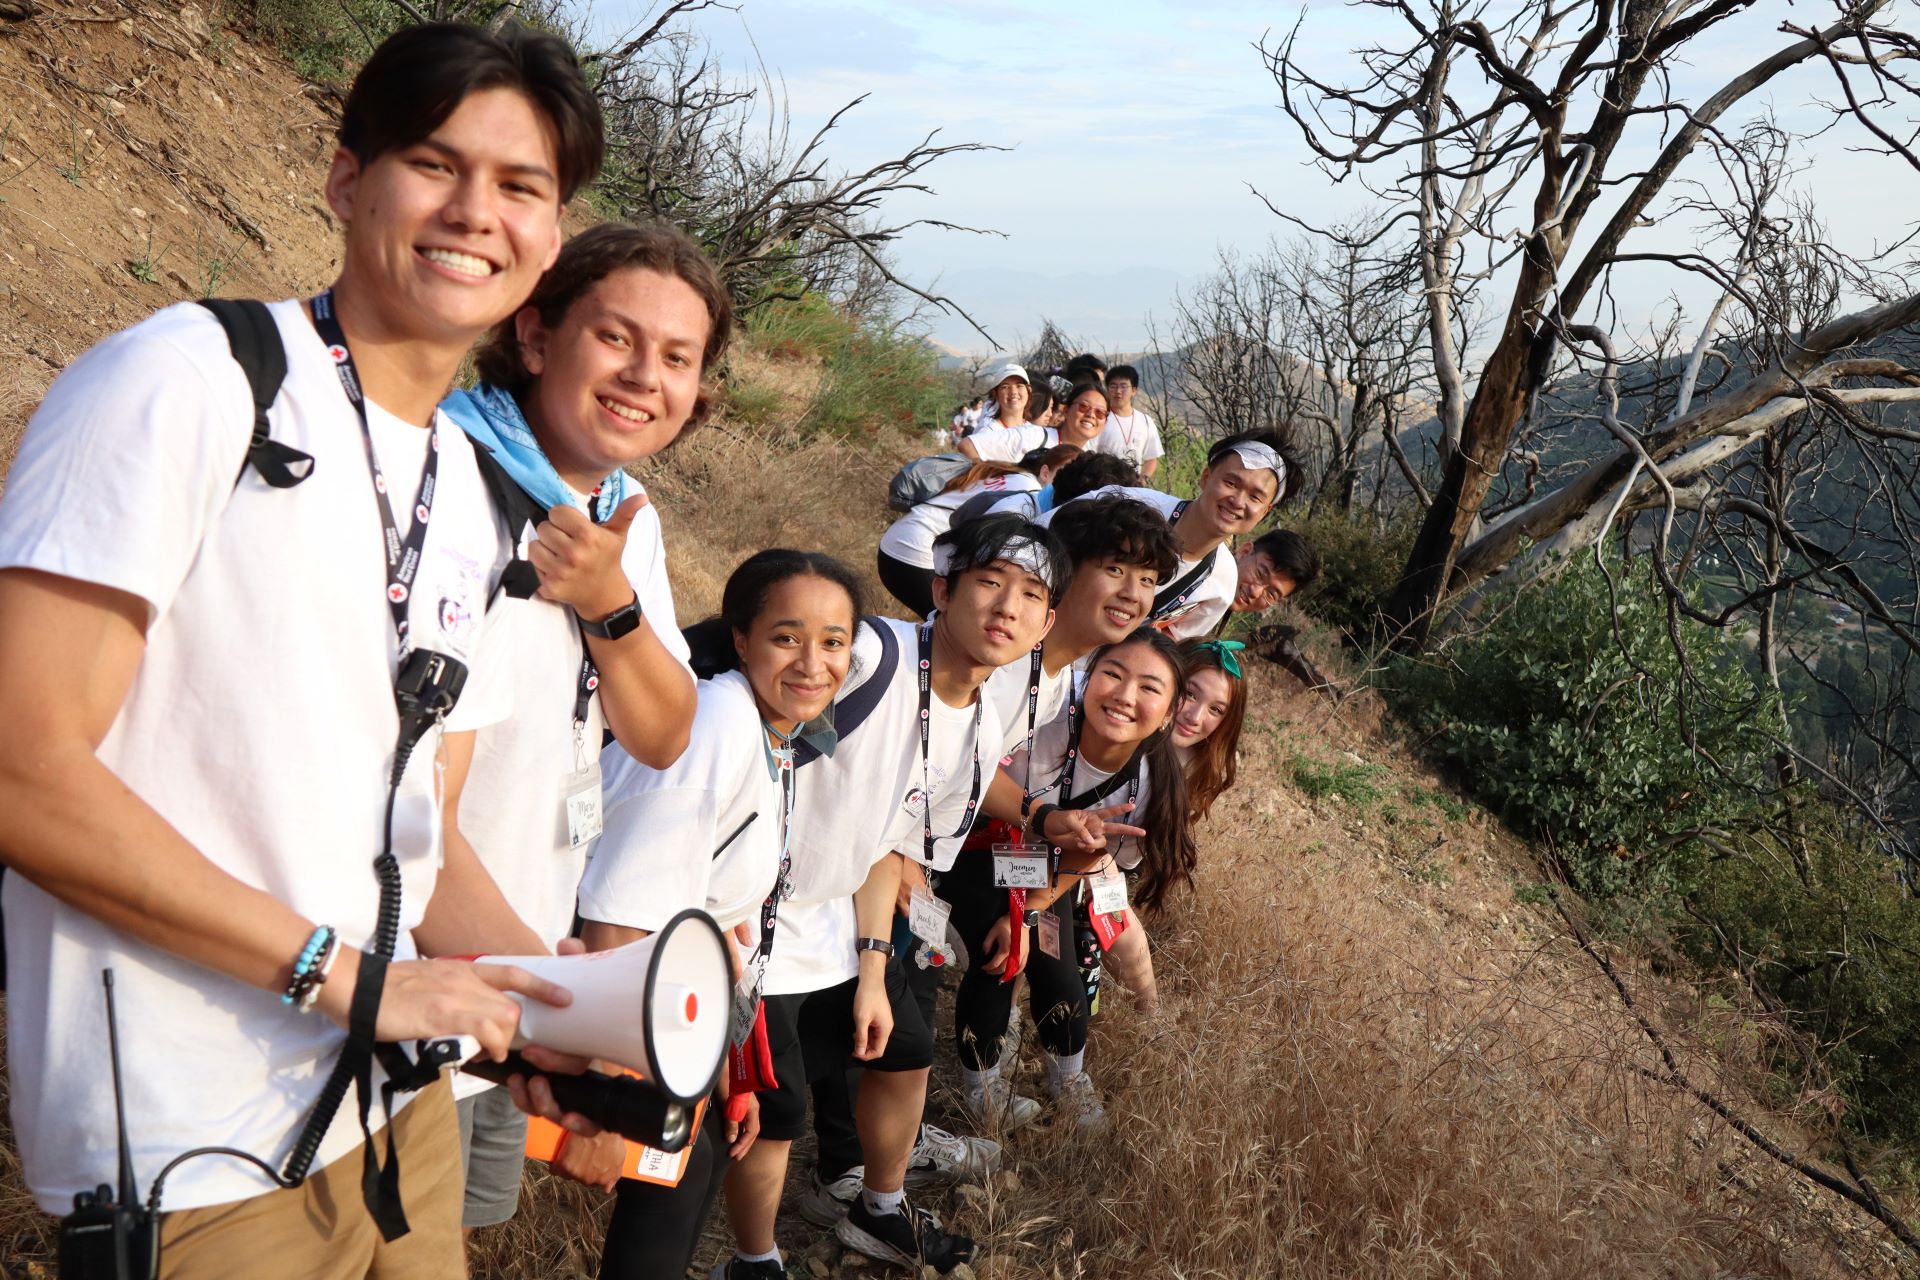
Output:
[460,386,1897,1280]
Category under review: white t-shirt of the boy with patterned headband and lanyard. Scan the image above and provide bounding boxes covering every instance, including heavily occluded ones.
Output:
[766,618,1002,994]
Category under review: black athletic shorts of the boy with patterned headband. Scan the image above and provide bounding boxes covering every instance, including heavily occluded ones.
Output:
[760,958,933,1142]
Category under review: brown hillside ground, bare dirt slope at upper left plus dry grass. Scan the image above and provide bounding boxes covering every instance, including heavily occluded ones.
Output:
[0,4,1910,1280]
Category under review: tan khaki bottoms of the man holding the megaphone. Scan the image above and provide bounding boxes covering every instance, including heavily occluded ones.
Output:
[159,1080,467,1280]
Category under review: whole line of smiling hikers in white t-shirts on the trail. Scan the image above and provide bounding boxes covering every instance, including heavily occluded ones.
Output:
[0,23,1319,1280]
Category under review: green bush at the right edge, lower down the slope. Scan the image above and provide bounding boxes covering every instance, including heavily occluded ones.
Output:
[1682,817,1920,1180]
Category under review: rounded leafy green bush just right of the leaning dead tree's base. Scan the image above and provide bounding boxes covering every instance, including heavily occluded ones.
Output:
[1382,558,1766,906]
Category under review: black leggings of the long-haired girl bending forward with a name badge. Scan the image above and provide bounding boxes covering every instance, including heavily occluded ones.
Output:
[939,848,1087,1071]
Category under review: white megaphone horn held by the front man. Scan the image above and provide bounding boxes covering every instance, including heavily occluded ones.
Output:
[476,910,733,1103]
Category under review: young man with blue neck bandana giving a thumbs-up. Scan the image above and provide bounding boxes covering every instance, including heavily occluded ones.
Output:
[436,223,733,1228]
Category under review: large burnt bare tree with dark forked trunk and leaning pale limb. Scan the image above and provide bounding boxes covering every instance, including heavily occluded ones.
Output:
[1261,0,1920,643]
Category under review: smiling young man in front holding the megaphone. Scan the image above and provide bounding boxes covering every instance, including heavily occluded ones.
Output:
[0,27,601,1280]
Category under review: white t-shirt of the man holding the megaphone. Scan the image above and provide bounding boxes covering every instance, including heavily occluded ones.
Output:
[0,301,511,1213]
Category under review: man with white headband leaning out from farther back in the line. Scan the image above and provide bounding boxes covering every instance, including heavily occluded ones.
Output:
[1035,432,1304,639]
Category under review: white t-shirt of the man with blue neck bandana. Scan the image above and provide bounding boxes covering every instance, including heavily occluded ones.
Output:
[461,486,687,948]
